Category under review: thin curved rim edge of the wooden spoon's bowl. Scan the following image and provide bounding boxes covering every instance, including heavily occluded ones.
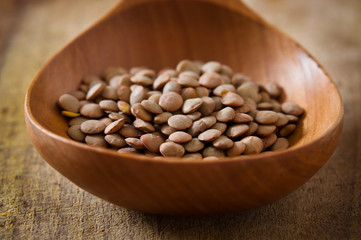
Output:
[24,2,344,164]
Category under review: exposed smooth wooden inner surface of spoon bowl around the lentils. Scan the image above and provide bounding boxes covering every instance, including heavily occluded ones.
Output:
[28,1,342,152]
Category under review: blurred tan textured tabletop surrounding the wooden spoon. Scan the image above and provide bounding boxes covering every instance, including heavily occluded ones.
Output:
[0,0,361,239]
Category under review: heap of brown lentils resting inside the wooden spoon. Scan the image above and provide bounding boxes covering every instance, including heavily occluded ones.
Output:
[58,60,304,159]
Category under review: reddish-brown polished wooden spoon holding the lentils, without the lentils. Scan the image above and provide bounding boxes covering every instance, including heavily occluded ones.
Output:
[25,0,343,215]
